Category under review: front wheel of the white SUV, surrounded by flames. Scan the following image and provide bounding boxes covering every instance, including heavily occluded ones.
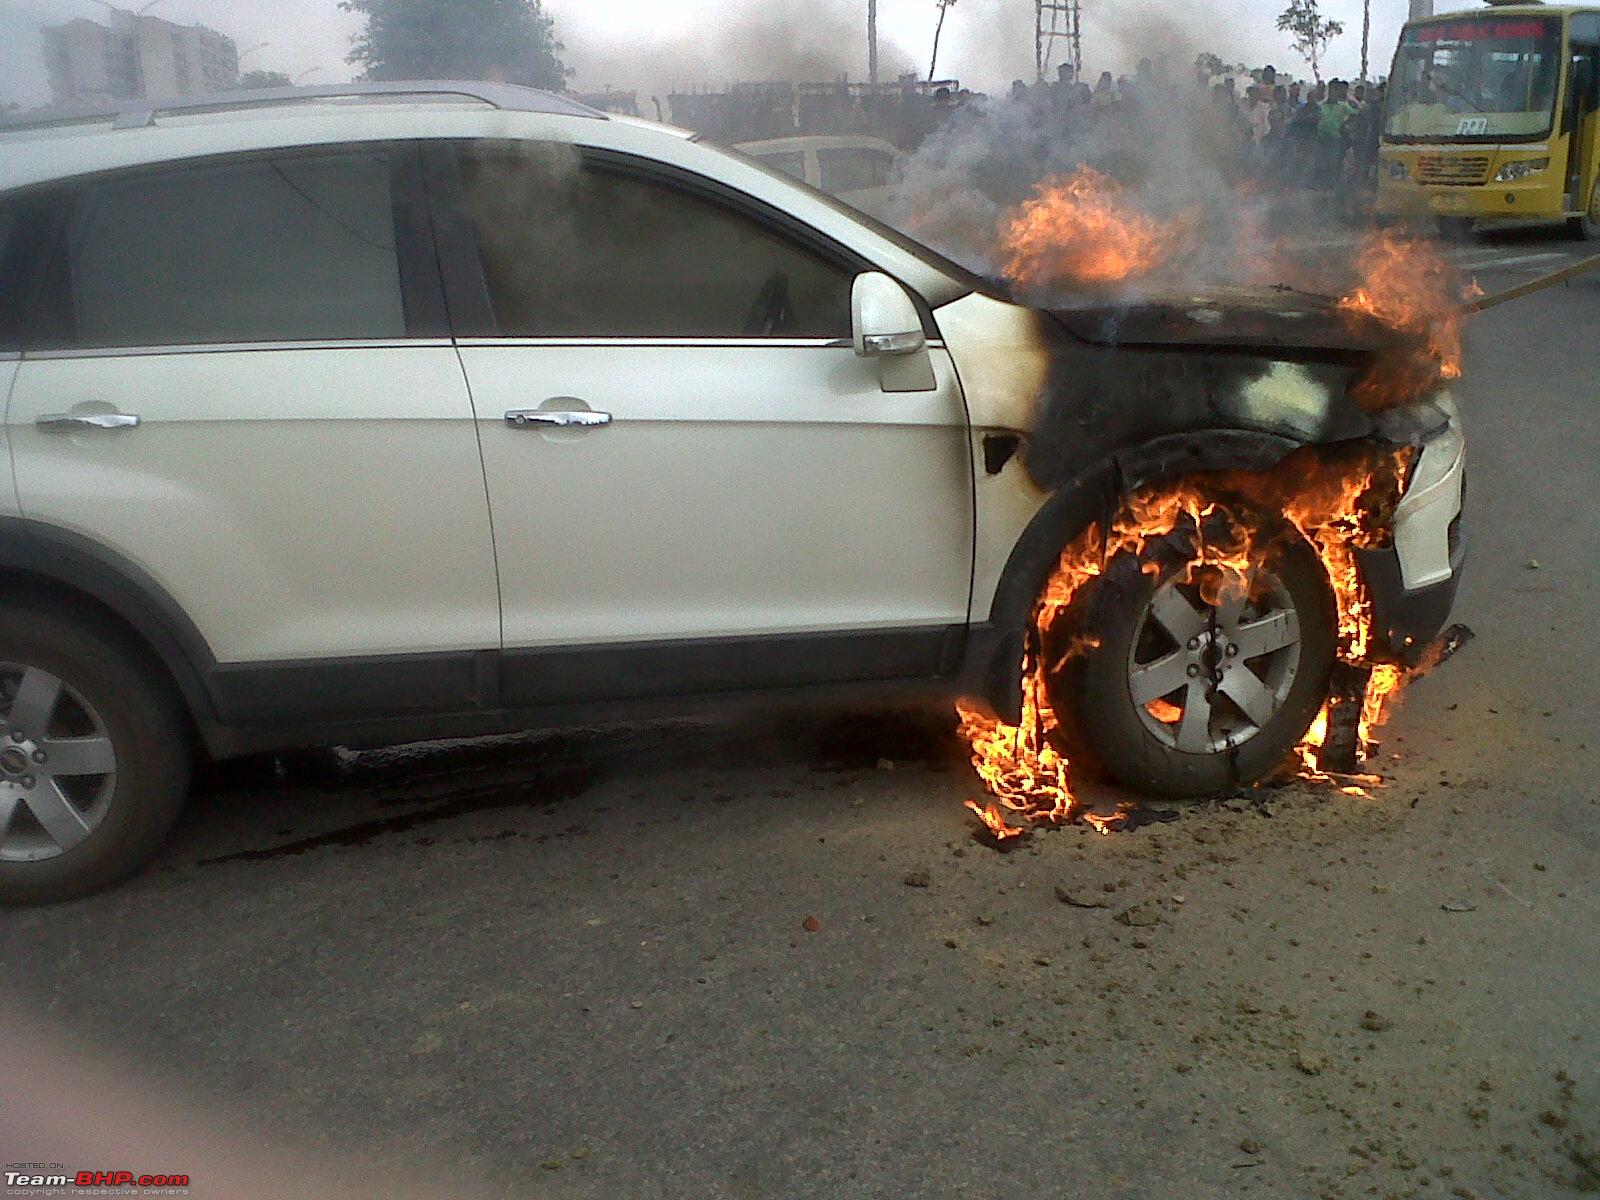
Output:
[1042,509,1338,798]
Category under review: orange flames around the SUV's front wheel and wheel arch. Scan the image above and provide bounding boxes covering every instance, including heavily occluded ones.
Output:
[955,451,1406,838]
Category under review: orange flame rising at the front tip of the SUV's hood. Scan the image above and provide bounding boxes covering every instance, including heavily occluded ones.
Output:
[1339,232,1482,410]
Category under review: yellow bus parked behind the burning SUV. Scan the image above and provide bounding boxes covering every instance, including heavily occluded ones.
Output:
[1378,0,1600,238]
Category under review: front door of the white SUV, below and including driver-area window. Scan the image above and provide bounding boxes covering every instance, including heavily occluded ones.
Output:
[440,144,973,702]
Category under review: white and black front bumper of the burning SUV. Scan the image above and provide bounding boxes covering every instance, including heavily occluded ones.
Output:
[1357,395,1467,666]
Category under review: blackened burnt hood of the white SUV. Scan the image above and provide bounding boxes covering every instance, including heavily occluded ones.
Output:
[1050,286,1395,360]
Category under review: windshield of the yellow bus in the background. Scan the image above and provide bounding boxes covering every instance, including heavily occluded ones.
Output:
[1384,18,1562,141]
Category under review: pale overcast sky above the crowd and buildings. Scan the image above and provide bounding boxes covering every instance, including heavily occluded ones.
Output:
[0,0,1480,106]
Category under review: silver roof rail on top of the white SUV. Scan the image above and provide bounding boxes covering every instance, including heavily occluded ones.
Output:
[0,80,606,133]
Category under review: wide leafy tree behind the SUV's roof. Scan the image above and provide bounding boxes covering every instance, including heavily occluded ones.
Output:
[339,0,571,88]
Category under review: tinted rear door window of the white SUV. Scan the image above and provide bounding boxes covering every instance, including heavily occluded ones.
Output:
[58,150,405,346]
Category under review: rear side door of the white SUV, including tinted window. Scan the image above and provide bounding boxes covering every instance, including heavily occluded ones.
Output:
[8,146,499,722]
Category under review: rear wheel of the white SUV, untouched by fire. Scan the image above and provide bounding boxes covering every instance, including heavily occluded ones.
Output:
[0,605,194,904]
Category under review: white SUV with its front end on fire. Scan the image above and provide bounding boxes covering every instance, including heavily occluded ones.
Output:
[0,83,1462,901]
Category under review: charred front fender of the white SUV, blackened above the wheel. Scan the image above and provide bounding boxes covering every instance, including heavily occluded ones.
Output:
[941,298,1395,722]
